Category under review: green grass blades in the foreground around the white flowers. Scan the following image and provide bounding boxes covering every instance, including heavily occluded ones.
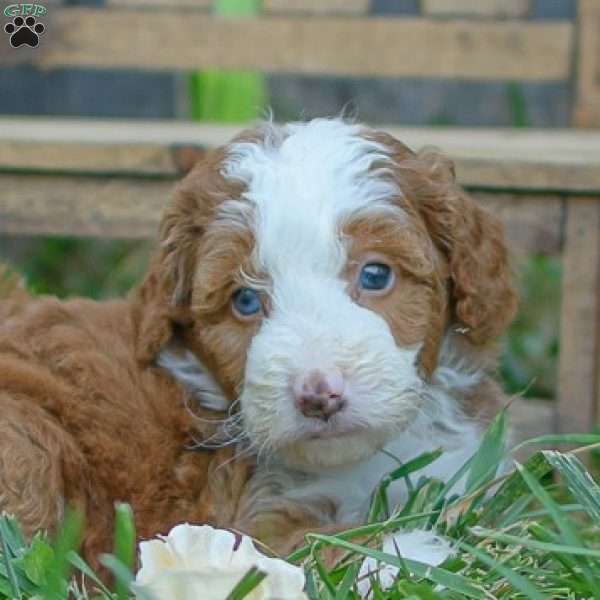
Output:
[0,412,600,600]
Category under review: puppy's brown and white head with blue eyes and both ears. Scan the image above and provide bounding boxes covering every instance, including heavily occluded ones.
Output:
[137,120,515,468]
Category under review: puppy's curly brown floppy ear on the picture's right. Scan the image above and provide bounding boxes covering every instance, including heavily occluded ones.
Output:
[399,150,517,345]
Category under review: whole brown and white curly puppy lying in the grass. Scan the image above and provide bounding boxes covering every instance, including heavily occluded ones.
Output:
[0,119,516,563]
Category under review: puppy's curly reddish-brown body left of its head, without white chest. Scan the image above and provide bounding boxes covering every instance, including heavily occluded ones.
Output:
[0,298,249,558]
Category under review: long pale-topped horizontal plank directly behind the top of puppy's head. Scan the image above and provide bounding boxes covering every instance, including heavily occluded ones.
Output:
[0,117,600,194]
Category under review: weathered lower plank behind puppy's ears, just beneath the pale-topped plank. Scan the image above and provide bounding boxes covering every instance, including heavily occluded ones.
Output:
[0,173,561,259]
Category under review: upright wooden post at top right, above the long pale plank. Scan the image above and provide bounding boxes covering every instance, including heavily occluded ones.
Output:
[574,0,600,127]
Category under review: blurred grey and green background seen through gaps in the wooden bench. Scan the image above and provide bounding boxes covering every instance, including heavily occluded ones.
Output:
[0,0,600,412]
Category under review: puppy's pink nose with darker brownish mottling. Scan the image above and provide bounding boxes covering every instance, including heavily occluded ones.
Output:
[294,369,346,421]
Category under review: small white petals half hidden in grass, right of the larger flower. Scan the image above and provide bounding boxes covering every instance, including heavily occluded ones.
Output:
[357,529,453,598]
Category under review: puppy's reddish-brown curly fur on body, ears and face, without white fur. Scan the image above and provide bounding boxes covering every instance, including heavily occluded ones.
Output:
[0,124,516,563]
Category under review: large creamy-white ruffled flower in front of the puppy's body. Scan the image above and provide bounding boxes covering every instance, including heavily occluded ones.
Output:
[134,523,306,600]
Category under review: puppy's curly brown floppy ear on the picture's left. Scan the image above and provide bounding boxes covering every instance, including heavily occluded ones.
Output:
[132,149,234,364]
